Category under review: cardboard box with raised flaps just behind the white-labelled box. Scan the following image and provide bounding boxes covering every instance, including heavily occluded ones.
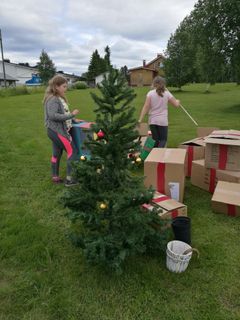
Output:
[178,138,206,177]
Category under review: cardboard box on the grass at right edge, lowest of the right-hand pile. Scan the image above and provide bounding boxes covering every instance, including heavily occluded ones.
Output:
[212,181,240,217]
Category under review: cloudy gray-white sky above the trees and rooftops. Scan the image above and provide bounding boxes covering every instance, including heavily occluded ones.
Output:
[0,0,197,75]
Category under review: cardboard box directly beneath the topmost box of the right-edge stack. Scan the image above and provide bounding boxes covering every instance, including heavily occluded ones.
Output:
[191,159,240,193]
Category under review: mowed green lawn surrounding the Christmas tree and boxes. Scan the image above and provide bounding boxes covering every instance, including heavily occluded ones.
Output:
[0,84,240,320]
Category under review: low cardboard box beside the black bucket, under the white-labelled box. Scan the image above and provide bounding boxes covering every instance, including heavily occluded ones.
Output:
[142,192,187,219]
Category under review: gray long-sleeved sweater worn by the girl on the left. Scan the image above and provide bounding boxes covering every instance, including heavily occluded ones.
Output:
[44,96,74,140]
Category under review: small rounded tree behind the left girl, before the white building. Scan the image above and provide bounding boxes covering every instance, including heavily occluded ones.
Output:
[38,50,56,84]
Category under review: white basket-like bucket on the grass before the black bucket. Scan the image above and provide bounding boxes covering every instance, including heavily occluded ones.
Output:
[166,240,192,273]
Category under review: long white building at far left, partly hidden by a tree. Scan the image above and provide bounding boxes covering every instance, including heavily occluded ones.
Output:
[0,61,80,86]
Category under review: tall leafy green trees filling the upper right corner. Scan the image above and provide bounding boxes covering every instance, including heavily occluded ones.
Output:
[164,0,240,90]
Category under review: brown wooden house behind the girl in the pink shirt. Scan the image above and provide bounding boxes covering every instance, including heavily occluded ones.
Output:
[128,54,164,87]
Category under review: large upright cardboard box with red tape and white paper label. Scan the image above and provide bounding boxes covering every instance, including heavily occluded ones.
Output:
[144,148,186,202]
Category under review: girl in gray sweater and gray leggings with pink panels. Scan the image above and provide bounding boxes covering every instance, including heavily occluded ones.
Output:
[43,75,79,186]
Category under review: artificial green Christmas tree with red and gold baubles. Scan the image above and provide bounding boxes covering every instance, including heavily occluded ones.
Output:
[63,69,170,271]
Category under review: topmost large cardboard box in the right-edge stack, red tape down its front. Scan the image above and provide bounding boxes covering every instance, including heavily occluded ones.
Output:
[205,130,240,171]
